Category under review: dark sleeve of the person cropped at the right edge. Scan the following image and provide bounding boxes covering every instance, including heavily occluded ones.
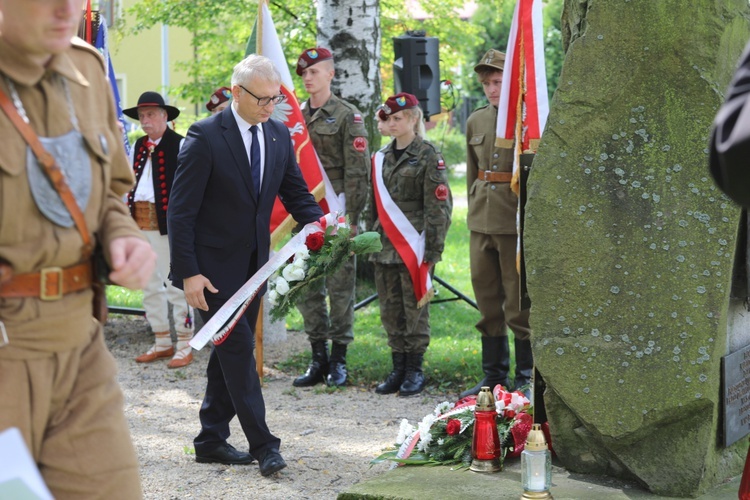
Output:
[709,43,750,207]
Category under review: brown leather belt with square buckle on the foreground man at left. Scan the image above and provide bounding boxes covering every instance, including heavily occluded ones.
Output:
[0,261,94,300]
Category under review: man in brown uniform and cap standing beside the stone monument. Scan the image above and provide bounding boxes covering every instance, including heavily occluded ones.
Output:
[461,49,533,397]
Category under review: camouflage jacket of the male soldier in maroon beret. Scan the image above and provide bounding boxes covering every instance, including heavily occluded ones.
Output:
[301,95,370,225]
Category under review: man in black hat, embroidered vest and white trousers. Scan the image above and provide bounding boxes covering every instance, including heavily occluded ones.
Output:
[123,92,193,368]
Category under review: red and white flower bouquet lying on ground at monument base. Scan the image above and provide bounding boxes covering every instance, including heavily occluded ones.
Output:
[372,385,533,468]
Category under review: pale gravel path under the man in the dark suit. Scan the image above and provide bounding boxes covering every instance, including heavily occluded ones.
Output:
[105,316,445,499]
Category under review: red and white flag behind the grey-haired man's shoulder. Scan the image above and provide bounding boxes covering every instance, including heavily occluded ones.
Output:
[253,0,343,246]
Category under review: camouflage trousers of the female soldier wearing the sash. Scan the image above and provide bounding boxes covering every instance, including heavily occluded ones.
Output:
[375,263,430,354]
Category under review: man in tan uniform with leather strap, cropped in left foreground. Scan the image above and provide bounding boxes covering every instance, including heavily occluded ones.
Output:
[0,0,156,499]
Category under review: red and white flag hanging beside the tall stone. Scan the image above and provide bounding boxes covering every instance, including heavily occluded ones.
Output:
[495,0,549,194]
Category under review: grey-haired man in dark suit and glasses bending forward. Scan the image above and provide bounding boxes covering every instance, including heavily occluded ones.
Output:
[168,55,323,476]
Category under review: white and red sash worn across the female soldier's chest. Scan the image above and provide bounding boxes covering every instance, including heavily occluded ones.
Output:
[372,150,434,307]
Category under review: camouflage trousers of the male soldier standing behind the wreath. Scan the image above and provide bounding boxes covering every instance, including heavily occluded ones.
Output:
[297,256,357,345]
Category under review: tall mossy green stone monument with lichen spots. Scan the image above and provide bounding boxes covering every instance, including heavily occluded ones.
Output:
[524,0,750,496]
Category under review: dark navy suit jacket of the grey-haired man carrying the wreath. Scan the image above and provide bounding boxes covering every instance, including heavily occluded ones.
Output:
[167,103,323,299]
